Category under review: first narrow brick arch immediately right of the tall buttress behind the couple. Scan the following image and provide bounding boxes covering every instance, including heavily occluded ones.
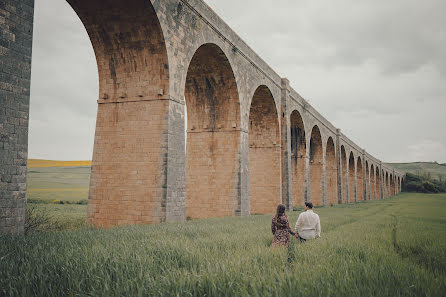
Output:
[290,110,307,205]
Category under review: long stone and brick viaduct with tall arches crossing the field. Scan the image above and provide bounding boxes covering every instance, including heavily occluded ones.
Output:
[0,0,404,232]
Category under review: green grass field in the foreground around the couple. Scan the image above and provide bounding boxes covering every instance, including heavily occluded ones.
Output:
[0,194,446,297]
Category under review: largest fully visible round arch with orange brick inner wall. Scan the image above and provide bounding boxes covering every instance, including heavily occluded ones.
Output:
[185,44,240,218]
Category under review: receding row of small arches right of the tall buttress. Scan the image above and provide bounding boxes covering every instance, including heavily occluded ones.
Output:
[290,110,401,205]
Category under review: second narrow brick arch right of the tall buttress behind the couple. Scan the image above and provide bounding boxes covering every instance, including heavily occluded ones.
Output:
[309,126,323,205]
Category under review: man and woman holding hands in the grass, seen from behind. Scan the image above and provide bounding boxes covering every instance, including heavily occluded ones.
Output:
[271,202,321,247]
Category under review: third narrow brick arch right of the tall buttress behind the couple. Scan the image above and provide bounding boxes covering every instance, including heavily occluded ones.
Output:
[325,137,338,204]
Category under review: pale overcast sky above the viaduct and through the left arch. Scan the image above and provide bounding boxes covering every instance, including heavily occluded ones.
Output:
[29,0,446,163]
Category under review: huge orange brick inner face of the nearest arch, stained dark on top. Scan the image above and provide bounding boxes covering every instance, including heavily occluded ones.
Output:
[68,0,169,227]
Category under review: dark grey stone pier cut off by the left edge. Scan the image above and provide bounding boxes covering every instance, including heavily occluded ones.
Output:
[0,0,34,234]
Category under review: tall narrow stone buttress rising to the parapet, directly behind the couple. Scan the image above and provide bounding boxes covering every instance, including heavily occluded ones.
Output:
[280,78,294,210]
